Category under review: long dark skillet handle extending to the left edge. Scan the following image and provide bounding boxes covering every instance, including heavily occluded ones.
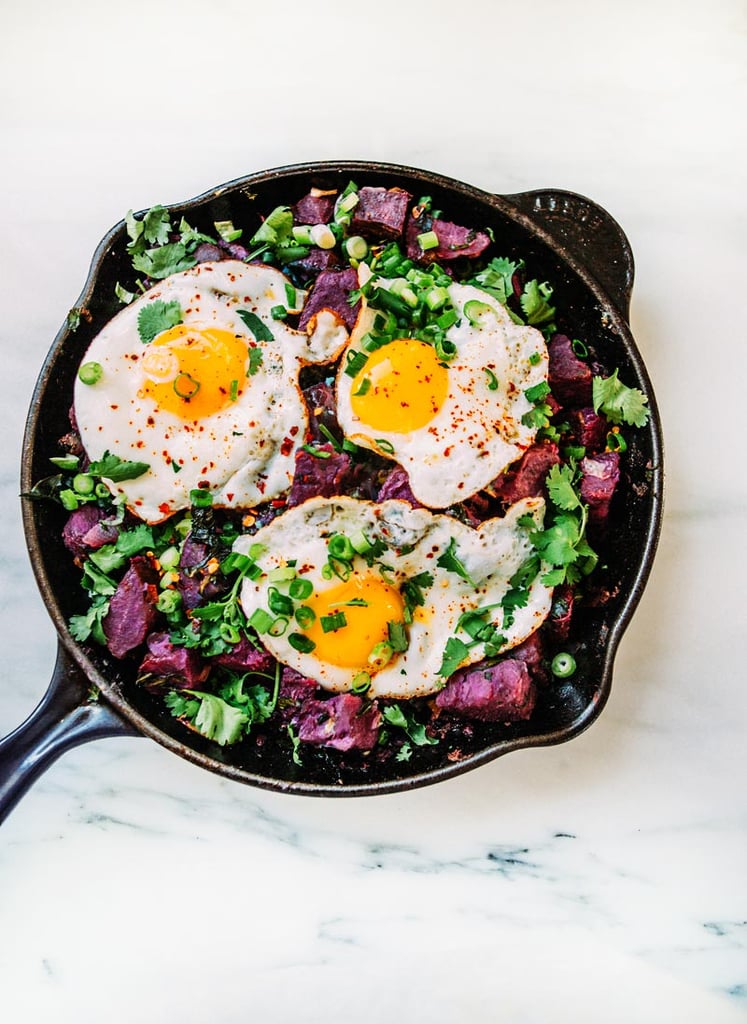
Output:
[0,645,137,822]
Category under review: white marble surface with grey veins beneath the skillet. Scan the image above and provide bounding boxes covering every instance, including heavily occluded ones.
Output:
[0,0,747,1024]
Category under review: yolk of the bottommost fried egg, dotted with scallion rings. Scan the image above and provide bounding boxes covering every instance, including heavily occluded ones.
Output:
[305,575,405,672]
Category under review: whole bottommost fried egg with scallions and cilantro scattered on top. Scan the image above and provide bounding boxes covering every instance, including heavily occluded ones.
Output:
[235,497,551,698]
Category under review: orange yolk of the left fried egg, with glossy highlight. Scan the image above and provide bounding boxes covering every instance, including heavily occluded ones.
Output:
[140,324,252,420]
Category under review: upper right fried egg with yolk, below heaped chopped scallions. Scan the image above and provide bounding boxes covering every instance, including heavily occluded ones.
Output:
[337,279,548,508]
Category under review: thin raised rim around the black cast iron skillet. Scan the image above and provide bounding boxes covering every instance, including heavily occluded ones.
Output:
[22,161,664,797]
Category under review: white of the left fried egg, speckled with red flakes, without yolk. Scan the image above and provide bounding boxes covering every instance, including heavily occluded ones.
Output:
[74,260,347,522]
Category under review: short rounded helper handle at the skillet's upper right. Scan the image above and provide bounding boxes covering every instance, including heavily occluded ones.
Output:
[503,188,635,319]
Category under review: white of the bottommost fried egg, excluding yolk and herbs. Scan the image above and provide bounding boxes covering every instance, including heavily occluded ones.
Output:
[235,497,552,698]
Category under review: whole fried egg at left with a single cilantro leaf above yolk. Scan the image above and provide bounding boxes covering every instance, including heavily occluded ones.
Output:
[74,260,347,522]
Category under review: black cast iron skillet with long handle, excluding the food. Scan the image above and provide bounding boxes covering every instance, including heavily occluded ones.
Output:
[0,161,663,820]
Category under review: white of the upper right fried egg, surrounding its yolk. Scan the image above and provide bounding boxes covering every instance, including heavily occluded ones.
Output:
[336,284,548,508]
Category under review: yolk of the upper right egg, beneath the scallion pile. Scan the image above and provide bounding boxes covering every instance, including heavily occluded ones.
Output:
[350,338,449,434]
